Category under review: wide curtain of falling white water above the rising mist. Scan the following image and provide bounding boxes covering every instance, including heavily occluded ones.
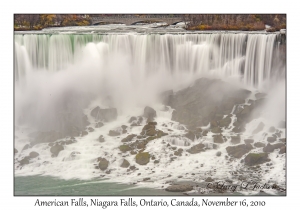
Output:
[15,33,279,88]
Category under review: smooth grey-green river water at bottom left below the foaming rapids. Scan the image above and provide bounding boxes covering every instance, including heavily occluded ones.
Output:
[14,176,183,196]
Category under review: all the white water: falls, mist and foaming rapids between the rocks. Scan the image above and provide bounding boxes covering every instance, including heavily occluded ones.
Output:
[14,32,285,194]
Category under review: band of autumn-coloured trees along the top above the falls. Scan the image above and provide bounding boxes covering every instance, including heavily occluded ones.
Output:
[14,14,286,31]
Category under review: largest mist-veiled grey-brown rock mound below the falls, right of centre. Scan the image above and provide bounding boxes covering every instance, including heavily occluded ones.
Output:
[169,78,250,129]
